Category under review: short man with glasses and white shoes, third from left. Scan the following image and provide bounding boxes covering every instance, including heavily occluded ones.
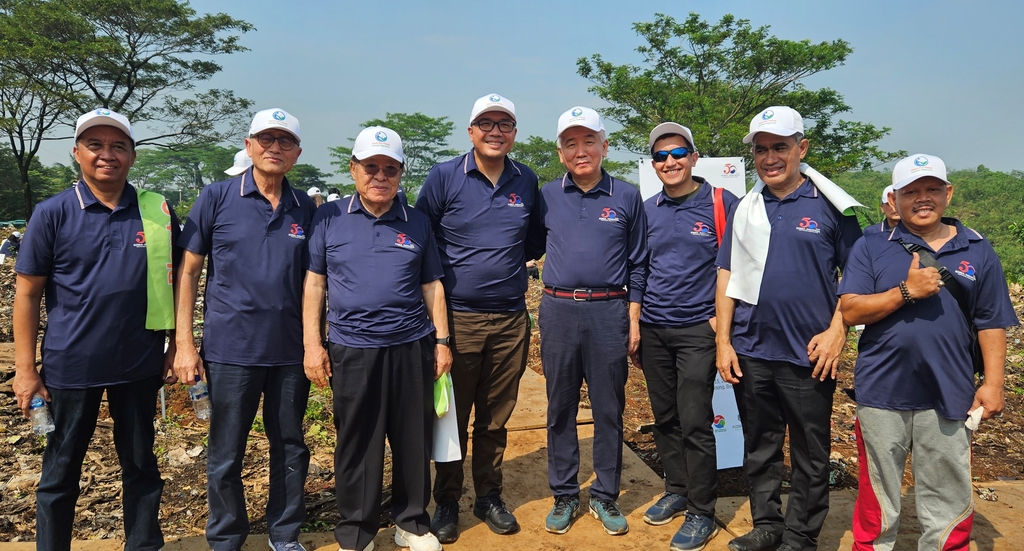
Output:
[303,126,452,551]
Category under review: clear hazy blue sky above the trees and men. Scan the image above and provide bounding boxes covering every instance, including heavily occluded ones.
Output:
[32,0,1024,179]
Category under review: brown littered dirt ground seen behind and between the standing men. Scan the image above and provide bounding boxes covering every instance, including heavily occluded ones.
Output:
[0,260,1024,541]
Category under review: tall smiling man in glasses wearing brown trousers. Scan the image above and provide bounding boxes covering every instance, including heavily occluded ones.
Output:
[416,94,544,543]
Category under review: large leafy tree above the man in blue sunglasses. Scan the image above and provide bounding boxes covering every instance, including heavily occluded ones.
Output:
[577,13,905,175]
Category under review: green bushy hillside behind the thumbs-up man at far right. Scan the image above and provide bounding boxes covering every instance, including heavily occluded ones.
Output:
[835,166,1024,283]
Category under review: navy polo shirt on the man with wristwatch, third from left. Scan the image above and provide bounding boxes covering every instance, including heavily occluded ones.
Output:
[309,195,444,348]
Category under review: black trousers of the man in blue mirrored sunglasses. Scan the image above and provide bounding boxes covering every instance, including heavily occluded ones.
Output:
[640,323,718,517]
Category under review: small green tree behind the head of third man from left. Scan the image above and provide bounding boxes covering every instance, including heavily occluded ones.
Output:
[330,113,459,197]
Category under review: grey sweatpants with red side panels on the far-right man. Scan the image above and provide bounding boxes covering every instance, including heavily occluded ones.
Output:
[853,407,974,551]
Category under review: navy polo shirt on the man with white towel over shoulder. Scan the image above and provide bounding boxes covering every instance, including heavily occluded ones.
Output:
[717,179,864,367]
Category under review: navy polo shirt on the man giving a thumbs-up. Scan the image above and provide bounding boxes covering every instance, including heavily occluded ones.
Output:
[839,218,1018,421]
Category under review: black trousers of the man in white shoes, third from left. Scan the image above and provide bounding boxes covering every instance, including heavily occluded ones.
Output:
[328,338,435,549]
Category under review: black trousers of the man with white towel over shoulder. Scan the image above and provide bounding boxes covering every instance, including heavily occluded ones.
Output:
[734,355,836,550]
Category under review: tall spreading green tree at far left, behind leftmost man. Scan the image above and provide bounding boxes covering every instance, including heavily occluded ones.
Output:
[0,0,252,215]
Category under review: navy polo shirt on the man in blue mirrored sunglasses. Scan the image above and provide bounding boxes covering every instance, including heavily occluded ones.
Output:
[640,176,739,327]
